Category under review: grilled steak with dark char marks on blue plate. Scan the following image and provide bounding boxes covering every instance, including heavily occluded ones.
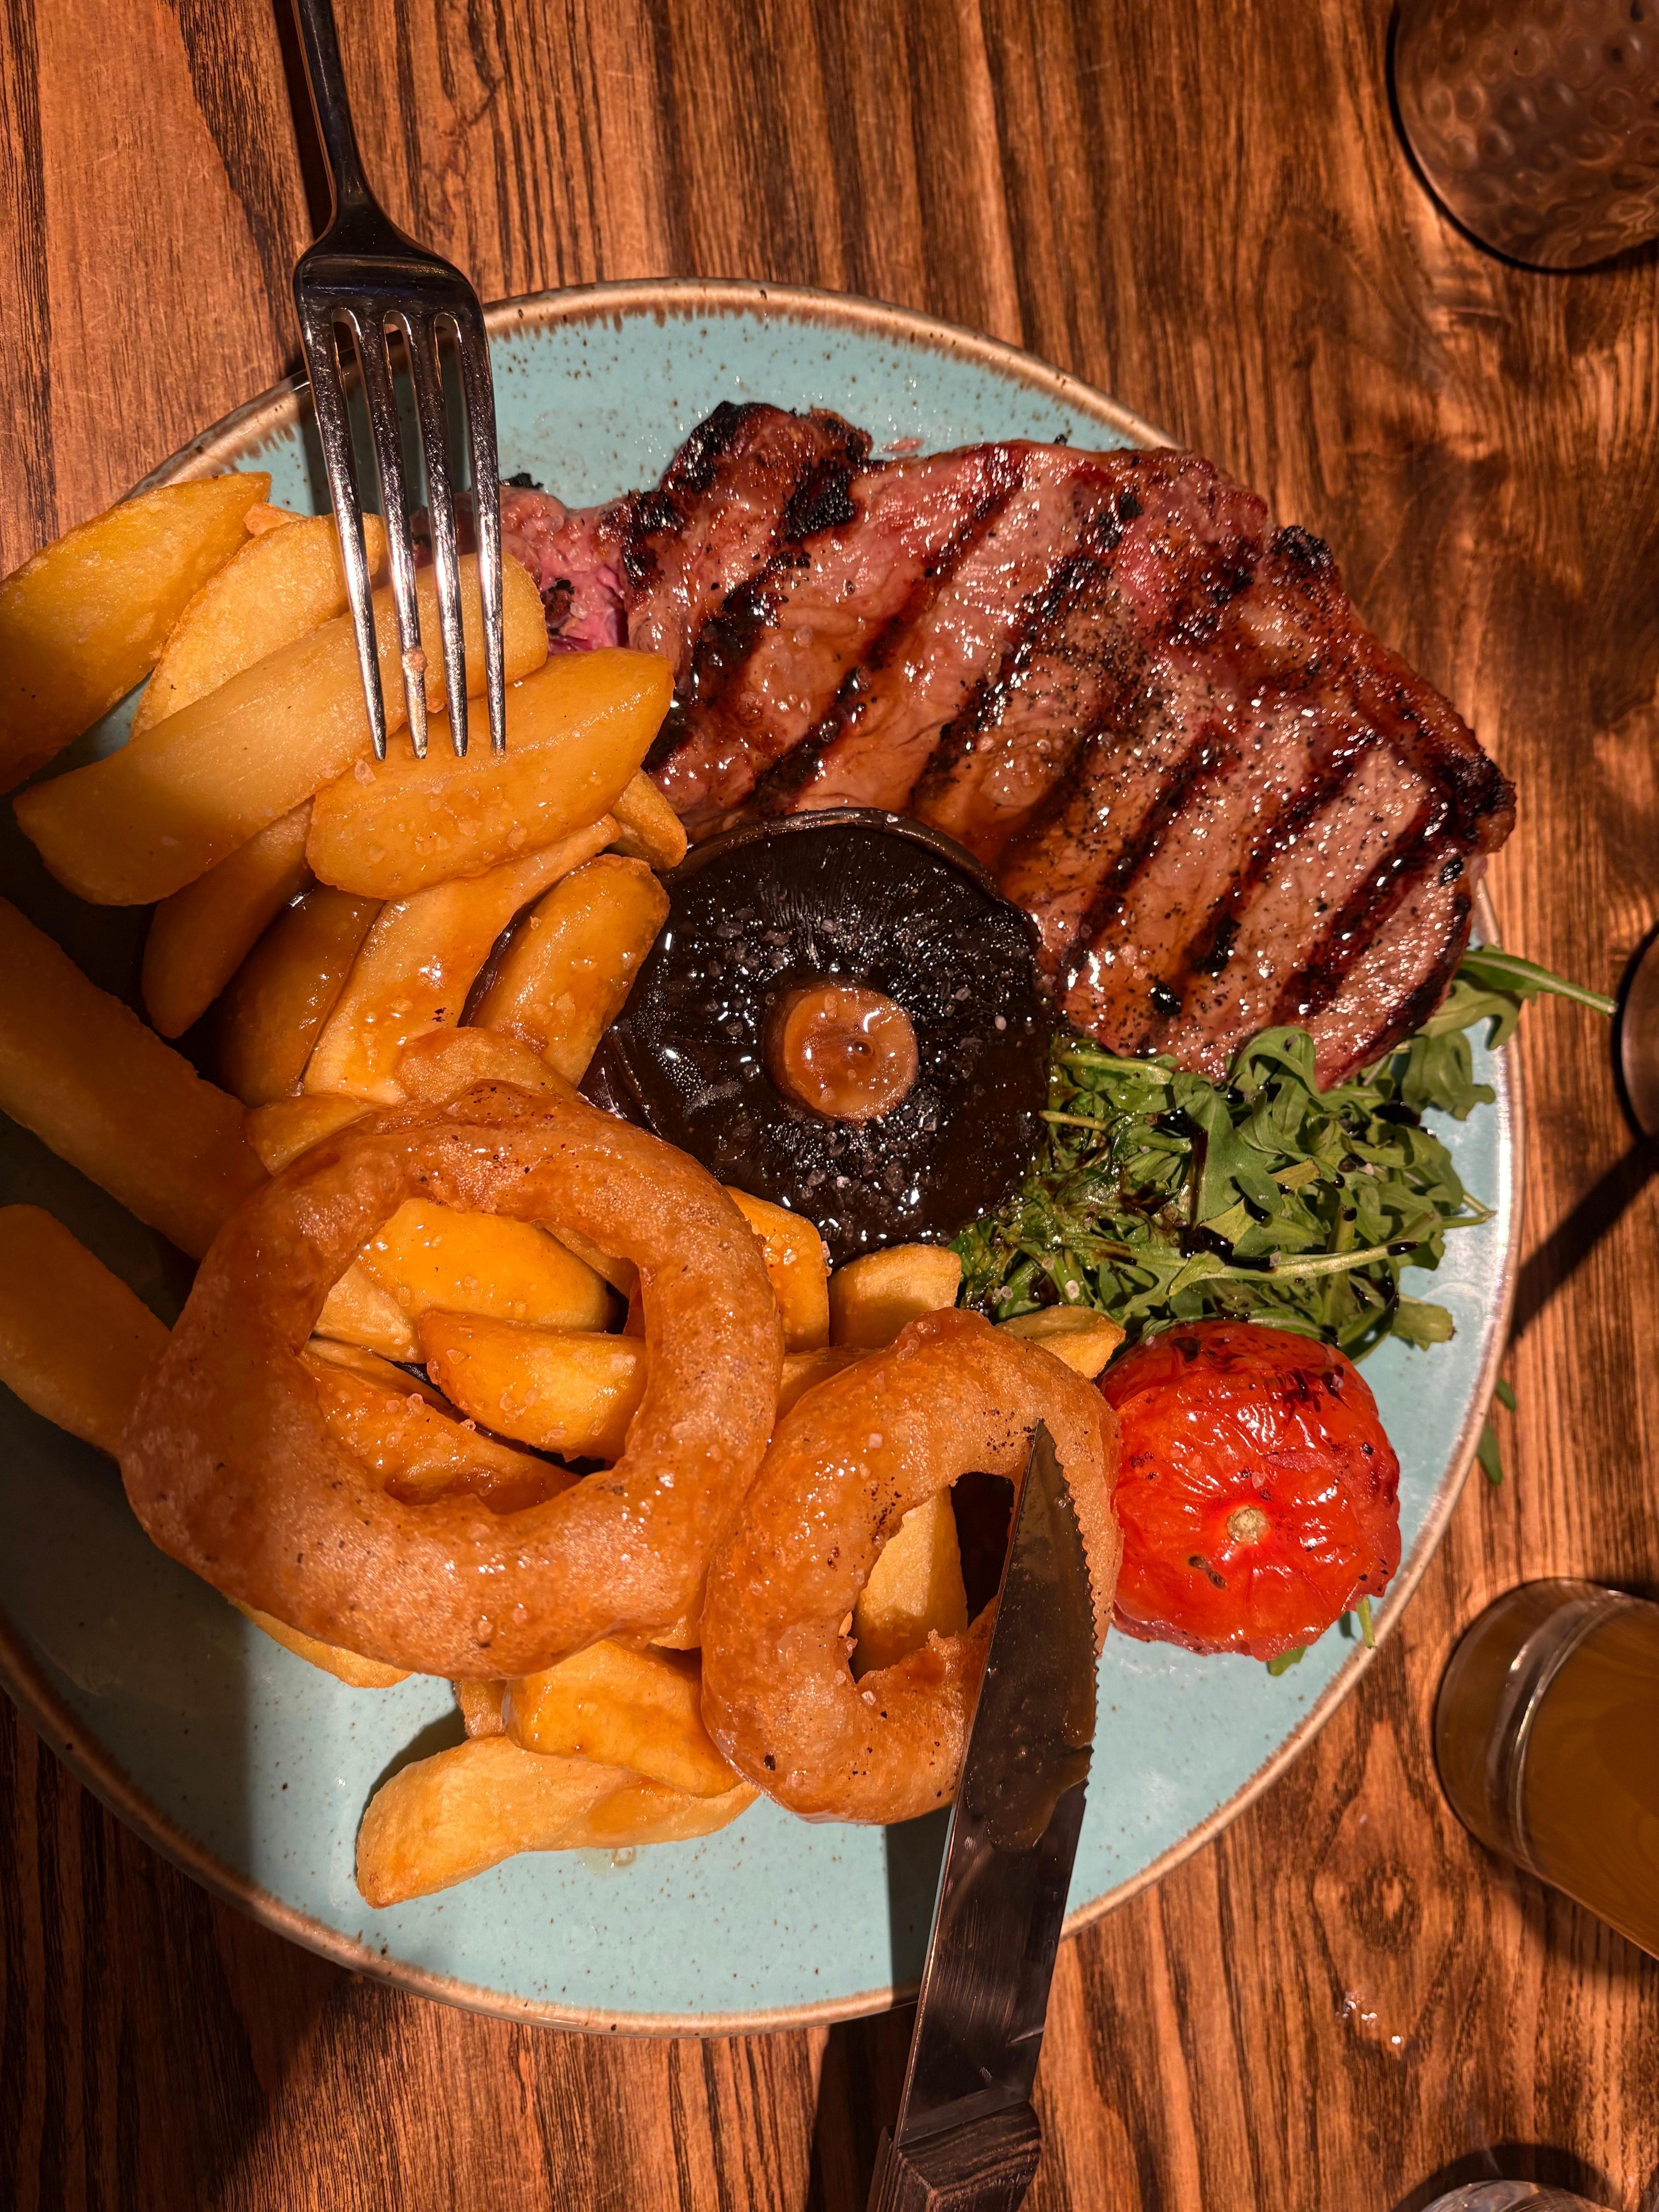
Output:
[504,407,1513,1084]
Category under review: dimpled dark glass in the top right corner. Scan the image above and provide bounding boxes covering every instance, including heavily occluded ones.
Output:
[1394,0,1659,270]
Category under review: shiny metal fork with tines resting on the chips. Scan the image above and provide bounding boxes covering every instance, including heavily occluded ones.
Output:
[294,0,507,761]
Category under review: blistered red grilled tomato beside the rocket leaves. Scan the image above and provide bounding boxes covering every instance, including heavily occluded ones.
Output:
[1099,1321,1400,1659]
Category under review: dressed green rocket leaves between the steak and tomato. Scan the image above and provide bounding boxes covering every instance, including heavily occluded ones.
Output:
[956,945,1615,1360]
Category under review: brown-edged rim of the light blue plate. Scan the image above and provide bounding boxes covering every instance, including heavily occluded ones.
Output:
[0,279,1524,2035]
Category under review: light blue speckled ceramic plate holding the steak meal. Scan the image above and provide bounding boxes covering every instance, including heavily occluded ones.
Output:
[0,283,1517,2031]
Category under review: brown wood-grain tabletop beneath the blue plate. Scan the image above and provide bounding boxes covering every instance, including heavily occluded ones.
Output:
[0,0,1659,2212]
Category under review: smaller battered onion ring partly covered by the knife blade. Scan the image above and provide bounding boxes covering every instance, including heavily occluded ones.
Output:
[703,1312,1121,1820]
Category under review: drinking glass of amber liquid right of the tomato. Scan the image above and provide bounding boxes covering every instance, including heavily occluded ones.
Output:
[1433,1579,1659,1958]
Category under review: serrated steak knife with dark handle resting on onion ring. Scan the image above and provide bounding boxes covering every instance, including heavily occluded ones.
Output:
[869,1427,1095,2212]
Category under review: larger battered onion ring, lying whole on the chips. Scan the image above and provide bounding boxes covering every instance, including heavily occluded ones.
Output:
[122,1084,783,1677]
